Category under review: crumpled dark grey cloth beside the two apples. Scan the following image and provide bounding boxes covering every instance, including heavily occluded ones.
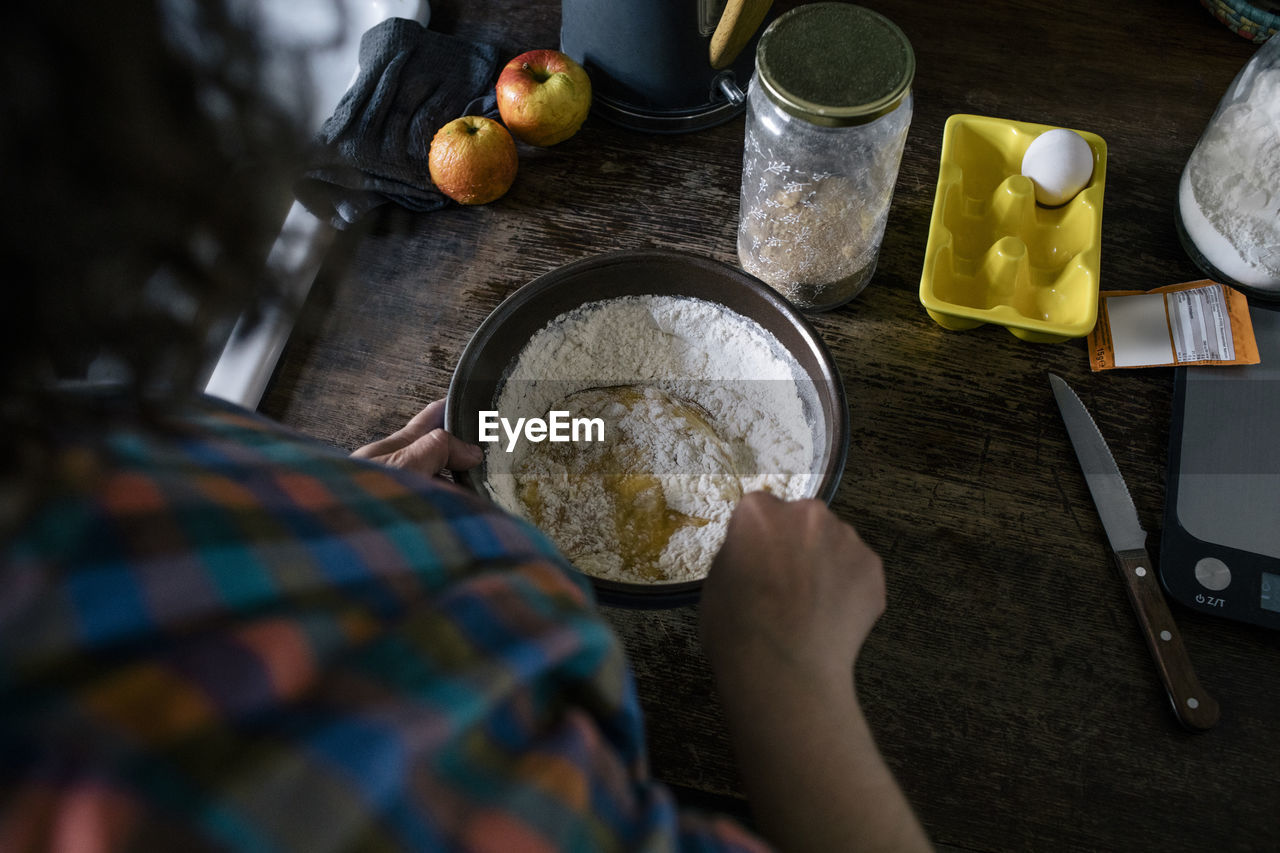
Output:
[294,18,498,229]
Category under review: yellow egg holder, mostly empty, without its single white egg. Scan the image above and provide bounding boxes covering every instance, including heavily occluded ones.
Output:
[920,115,1107,343]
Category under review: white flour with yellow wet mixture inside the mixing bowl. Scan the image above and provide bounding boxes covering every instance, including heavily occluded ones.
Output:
[485,296,824,583]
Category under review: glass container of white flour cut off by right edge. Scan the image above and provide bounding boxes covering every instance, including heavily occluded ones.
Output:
[1178,36,1280,300]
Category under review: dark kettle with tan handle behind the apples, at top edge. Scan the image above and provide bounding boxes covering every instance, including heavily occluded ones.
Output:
[561,0,772,133]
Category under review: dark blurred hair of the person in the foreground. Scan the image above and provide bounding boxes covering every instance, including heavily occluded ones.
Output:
[0,0,320,466]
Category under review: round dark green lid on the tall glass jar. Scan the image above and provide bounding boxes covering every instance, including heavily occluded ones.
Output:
[755,3,915,127]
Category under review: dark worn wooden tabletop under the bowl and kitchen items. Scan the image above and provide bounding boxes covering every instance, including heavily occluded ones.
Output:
[254,0,1280,853]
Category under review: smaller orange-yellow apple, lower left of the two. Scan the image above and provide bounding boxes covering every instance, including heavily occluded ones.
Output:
[426,115,517,205]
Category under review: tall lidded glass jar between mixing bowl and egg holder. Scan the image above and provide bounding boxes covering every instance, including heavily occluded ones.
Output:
[737,3,915,311]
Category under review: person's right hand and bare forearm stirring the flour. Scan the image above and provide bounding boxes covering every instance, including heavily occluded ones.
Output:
[700,492,929,853]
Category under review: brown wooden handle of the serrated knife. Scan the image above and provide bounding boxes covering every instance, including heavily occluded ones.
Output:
[1116,548,1219,731]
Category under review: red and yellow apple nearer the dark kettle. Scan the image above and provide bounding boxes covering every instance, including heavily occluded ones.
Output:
[497,50,591,145]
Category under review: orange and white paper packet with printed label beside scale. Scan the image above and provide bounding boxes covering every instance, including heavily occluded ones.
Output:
[1089,279,1258,371]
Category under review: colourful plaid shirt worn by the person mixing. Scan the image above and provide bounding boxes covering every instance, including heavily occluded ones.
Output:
[0,402,760,853]
